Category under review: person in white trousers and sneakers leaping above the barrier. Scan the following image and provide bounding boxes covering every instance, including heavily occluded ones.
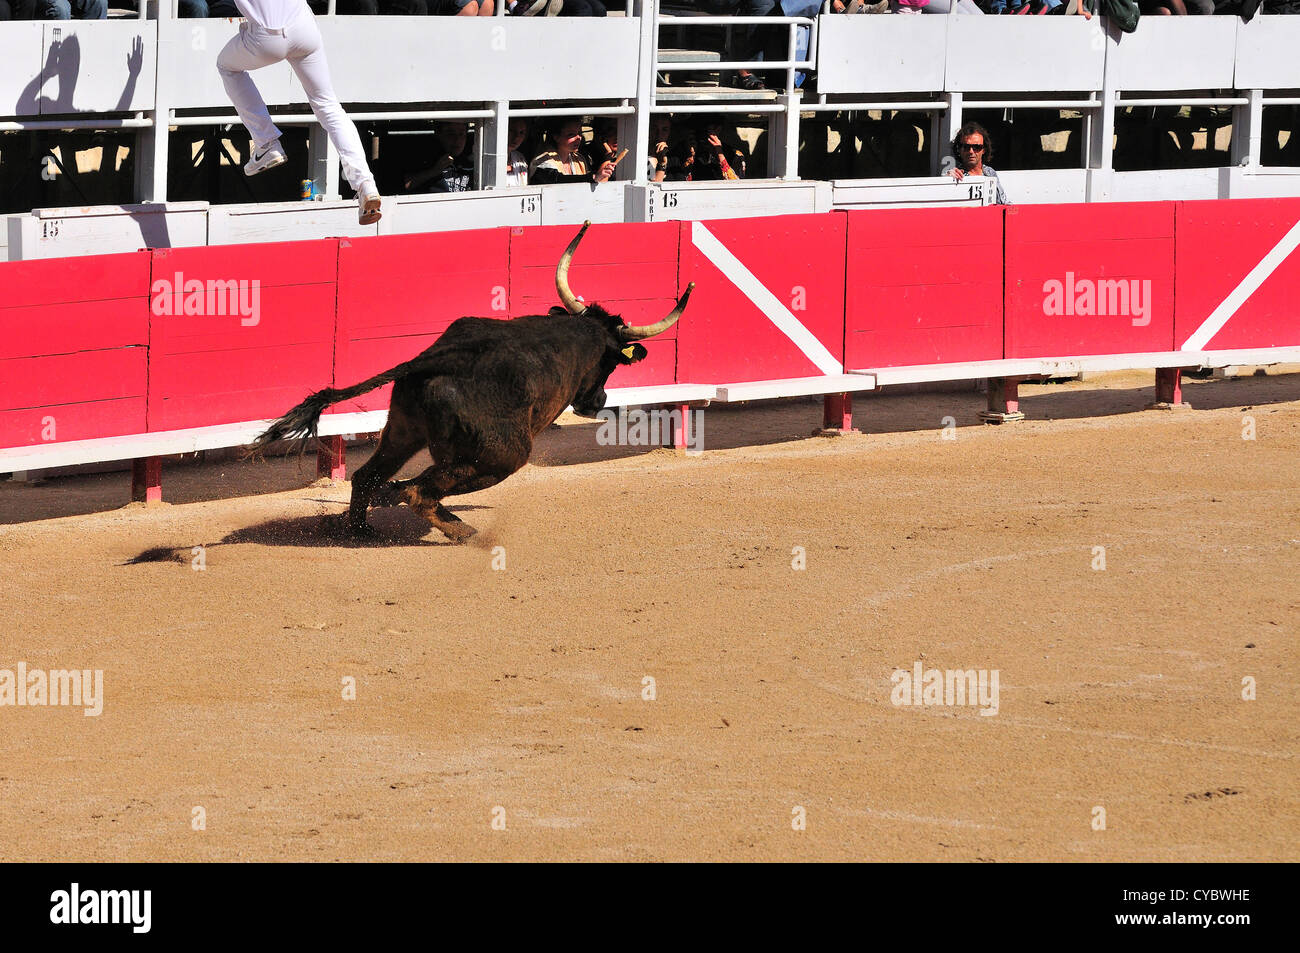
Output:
[217,0,382,225]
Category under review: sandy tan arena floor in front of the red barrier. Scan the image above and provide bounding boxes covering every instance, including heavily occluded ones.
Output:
[0,373,1300,861]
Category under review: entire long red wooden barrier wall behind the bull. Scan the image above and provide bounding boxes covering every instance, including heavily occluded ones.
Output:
[0,199,1300,460]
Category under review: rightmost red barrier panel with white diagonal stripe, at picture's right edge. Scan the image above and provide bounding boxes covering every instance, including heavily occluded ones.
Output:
[1174,199,1300,351]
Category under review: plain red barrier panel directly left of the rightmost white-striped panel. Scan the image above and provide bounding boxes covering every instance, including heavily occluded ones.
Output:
[1004,202,1175,358]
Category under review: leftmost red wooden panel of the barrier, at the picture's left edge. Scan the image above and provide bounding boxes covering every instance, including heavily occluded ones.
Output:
[0,252,150,447]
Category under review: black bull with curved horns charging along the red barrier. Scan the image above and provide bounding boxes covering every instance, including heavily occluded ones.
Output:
[254,222,694,542]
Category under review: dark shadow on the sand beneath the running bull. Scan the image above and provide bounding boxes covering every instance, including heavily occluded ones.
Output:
[122,499,493,566]
